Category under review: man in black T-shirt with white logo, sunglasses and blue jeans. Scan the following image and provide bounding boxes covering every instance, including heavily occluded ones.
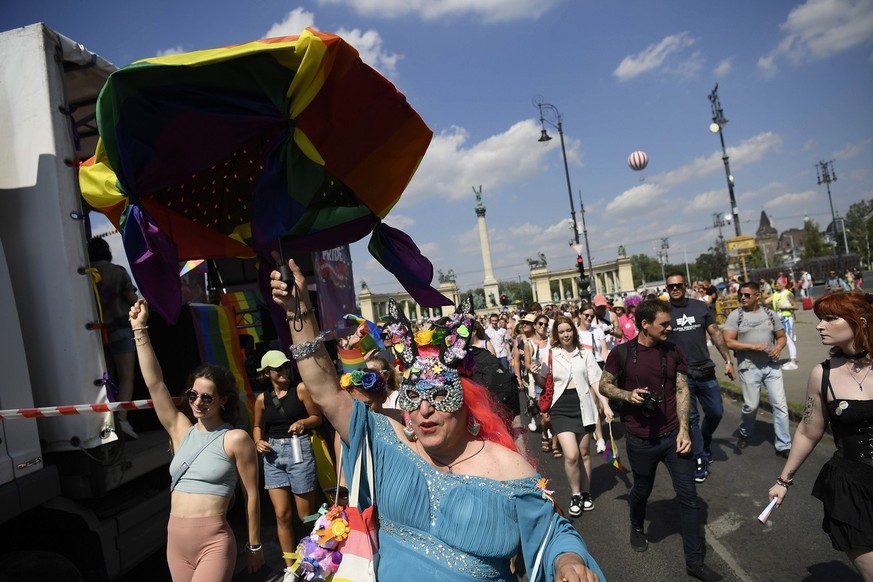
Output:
[667,271,734,483]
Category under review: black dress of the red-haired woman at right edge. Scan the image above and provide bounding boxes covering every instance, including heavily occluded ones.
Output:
[812,361,873,552]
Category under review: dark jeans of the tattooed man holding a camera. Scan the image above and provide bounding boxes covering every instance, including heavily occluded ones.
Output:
[626,431,706,565]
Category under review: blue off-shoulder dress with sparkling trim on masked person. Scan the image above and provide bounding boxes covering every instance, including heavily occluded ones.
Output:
[343,401,605,582]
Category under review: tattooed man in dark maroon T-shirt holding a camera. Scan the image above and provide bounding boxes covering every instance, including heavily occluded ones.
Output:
[600,299,721,581]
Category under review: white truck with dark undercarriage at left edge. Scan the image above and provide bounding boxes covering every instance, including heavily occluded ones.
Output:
[0,24,170,580]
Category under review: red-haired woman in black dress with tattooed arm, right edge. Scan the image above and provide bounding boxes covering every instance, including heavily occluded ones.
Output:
[769,291,873,582]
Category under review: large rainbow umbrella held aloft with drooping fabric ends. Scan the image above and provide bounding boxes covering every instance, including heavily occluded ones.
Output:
[79,29,449,321]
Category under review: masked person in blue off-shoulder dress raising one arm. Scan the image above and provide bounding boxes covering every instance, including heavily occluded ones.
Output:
[271,257,602,582]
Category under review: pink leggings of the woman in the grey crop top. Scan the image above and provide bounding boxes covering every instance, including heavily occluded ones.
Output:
[167,515,236,582]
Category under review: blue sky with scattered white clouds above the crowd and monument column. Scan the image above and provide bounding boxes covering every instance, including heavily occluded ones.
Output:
[6,0,873,292]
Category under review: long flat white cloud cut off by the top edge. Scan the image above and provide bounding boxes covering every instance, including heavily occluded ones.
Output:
[319,0,561,23]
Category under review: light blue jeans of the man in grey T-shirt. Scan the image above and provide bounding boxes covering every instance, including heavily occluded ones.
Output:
[739,362,791,451]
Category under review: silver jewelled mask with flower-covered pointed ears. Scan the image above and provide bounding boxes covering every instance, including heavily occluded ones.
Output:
[385,297,474,412]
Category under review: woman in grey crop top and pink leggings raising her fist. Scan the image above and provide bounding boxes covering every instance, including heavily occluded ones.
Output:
[130,299,264,582]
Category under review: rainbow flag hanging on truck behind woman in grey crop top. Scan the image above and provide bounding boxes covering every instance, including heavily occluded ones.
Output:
[190,303,255,432]
